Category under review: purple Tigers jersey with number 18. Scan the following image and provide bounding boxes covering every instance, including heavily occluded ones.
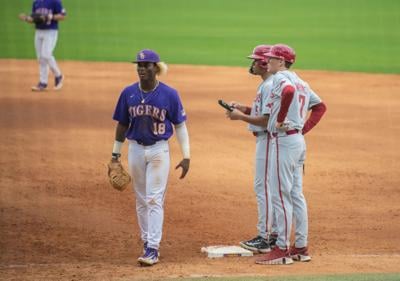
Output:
[113,82,186,145]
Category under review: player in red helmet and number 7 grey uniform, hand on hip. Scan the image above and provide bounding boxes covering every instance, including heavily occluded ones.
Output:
[256,44,326,264]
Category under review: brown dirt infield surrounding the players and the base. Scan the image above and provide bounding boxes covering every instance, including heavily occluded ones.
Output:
[0,60,400,280]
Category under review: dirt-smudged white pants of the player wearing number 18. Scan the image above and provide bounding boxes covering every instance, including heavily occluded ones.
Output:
[128,141,170,249]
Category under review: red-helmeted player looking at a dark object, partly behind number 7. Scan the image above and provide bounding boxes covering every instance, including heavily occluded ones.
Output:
[226,45,276,253]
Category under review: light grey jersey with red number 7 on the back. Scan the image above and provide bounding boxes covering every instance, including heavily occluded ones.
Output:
[267,70,321,132]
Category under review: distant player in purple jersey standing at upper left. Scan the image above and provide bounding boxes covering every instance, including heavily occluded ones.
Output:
[19,0,66,91]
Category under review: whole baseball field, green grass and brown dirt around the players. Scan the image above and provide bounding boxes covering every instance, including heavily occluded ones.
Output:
[0,0,400,281]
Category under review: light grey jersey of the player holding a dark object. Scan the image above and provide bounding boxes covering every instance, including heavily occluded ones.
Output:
[248,75,273,132]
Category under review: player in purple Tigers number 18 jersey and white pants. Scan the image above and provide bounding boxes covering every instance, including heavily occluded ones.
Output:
[112,49,190,265]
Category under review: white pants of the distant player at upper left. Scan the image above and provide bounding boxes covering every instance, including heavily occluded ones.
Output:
[35,29,61,85]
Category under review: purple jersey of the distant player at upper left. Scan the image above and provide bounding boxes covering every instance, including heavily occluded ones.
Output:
[32,0,66,29]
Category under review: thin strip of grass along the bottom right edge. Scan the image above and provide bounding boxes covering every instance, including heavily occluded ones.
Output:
[166,273,400,281]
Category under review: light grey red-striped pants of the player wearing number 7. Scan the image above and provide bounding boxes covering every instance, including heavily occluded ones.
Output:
[270,133,308,249]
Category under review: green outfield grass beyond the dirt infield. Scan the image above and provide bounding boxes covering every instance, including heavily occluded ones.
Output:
[0,0,400,73]
